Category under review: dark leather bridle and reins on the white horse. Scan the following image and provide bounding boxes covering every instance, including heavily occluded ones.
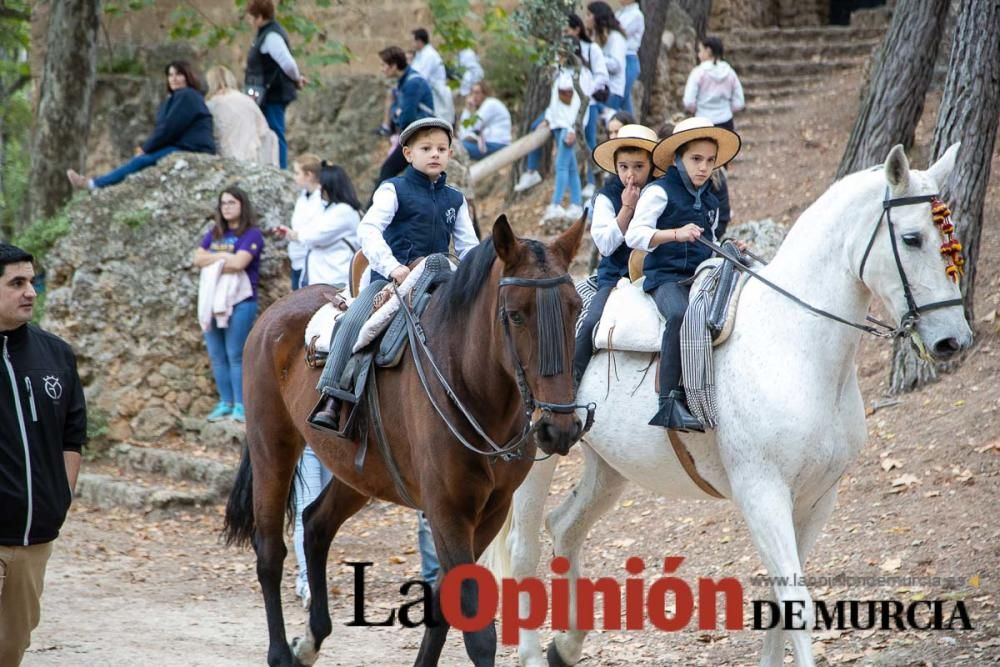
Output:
[696,187,962,338]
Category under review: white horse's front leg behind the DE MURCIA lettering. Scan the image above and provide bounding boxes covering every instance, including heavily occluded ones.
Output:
[731,468,816,667]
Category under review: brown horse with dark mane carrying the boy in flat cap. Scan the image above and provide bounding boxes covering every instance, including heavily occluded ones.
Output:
[224,216,592,667]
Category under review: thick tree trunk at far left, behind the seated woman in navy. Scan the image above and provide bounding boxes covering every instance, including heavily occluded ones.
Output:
[28,0,101,221]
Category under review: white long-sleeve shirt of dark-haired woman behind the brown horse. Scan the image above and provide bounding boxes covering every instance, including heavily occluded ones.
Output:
[299,202,361,286]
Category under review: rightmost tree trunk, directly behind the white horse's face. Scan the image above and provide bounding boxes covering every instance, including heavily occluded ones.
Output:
[890,0,1000,393]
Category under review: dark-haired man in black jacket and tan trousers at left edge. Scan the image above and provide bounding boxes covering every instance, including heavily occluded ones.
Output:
[0,243,87,667]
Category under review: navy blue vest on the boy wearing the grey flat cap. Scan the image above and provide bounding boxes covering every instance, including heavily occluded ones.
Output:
[372,165,465,280]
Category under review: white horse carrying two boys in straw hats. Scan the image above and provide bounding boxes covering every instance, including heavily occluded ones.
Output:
[484,145,972,667]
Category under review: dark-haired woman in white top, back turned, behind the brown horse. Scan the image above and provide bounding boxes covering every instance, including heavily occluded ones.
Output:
[279,161,361,287]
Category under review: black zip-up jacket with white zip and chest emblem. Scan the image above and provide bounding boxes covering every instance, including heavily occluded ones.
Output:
[0,324,87,546]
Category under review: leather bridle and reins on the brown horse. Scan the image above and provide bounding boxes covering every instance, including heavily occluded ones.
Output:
[393,273,597,461]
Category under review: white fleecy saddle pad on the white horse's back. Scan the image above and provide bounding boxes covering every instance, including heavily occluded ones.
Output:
[594,277,665,352]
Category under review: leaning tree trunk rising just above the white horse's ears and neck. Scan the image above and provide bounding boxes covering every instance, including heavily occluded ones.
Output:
[837,0,949,178]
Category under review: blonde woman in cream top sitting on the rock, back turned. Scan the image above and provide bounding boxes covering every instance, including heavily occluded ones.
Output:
[205,65,278,166]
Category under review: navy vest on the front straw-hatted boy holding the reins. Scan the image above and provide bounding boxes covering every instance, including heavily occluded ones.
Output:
[642,166,719,292]
